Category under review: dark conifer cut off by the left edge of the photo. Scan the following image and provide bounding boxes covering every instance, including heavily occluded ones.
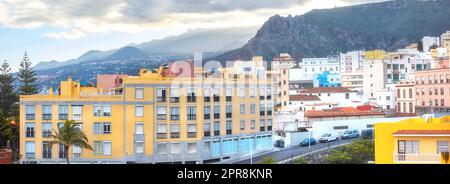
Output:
[0,60,17,117]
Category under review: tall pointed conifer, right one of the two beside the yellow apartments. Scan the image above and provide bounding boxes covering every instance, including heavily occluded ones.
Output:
[19,52,38,95]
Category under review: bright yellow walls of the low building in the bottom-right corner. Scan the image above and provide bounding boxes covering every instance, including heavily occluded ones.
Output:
[374,116,450,164]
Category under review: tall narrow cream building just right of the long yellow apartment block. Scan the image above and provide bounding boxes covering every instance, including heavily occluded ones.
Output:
[271,53,296,111]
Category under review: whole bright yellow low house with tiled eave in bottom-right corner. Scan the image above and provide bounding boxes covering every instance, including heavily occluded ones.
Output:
[374,116,450,164]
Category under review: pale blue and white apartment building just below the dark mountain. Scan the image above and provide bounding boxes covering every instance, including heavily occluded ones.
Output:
[289,56,341,81]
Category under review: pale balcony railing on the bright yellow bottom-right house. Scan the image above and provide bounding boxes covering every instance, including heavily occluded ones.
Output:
[394,154,441,164]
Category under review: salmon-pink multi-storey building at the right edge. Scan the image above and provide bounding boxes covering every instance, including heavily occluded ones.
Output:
[414,68,450,114]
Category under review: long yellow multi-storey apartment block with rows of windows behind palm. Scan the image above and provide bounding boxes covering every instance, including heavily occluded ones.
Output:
[20,62,273,163]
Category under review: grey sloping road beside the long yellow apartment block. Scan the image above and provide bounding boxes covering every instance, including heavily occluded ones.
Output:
[231,138,359,164]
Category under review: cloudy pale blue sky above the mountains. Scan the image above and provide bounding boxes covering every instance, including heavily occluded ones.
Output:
[0,0,383,71]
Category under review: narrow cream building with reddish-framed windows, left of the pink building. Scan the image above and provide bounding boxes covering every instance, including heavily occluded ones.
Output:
[395,81,416,115]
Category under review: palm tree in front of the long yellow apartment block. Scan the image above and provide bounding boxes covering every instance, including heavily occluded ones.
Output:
[51,120,93,164]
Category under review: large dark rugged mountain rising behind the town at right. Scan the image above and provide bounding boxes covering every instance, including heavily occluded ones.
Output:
[213,0,450,61]
